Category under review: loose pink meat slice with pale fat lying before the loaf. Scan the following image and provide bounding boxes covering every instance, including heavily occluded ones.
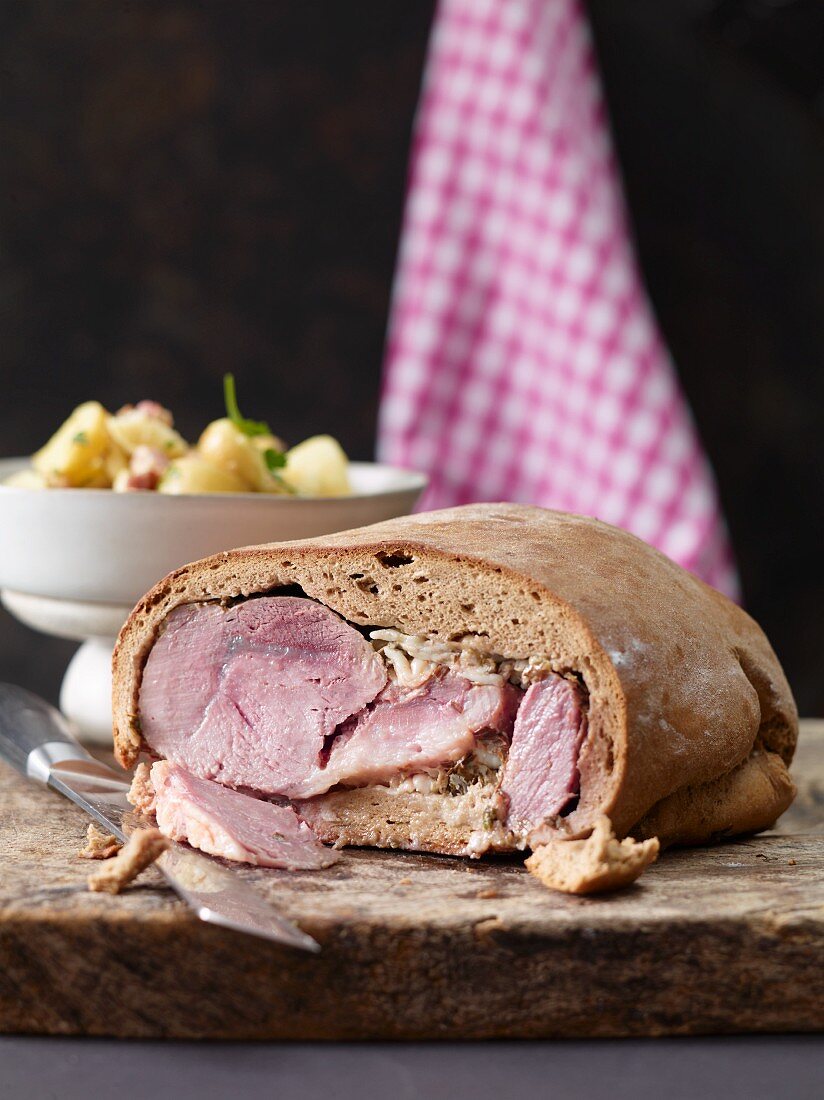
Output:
[151,760,339,871]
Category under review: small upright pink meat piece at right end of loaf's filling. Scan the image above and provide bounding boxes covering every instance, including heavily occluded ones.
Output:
[501,675,586,829]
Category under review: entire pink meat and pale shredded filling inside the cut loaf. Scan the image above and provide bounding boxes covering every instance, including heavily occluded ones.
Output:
[140,596,586,836]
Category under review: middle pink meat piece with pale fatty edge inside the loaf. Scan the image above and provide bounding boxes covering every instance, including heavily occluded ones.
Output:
[287,672,520,799]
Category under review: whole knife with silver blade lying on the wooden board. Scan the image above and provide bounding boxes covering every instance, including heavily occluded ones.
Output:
[0,683,320,952]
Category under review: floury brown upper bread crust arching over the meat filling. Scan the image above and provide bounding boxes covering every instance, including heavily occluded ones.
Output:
[113,504,798,843]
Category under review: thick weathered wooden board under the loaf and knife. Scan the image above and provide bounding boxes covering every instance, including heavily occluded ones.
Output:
[0,723,824,1038]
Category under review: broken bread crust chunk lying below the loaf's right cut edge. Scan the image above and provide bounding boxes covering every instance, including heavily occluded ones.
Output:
[526,816,660,894]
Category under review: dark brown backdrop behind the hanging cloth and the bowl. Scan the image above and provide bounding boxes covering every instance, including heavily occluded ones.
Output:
[0,0,824,714]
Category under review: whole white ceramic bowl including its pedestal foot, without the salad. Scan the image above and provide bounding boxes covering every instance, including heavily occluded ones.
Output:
[0,459,427,743]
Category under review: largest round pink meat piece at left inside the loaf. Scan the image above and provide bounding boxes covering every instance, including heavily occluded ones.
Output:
[140,596,386,794]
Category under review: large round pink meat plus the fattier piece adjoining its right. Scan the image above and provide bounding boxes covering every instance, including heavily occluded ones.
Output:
[140,596,519,799]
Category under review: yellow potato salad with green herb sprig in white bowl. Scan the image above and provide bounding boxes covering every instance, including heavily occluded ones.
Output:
[6,374,351,496]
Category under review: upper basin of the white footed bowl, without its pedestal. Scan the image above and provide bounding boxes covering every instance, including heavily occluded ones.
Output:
[0,459,426,605]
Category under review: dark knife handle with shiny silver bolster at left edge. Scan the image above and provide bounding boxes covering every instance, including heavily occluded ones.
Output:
[0,683,94,783]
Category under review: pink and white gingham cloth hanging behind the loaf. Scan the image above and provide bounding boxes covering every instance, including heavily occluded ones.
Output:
[378,0,738,596]
